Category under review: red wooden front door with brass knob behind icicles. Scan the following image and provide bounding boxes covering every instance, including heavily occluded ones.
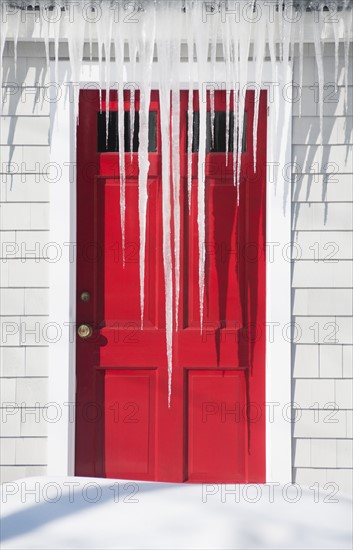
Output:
[76,91,266,483]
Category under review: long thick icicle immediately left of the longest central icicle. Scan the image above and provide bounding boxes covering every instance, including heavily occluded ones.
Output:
[138,4,155,334]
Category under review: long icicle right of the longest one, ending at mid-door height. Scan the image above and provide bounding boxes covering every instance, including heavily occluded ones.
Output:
[192,4,209,334]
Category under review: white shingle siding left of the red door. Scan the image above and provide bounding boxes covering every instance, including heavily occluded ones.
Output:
[0,45,50,488]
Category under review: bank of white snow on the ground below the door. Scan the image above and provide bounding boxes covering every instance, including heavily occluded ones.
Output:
[1,477,352,550]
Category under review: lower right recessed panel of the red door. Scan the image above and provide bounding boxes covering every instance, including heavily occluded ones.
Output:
[188,369,246,482]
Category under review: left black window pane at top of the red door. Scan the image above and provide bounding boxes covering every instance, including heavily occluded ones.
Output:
[97,111,157,153]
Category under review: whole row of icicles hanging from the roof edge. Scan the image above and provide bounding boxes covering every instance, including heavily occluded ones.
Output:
[0,0,352,406]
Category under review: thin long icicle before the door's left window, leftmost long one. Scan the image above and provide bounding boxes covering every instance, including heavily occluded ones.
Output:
[114,23,126,267]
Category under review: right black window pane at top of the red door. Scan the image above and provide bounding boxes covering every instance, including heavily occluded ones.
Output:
[186,111,246,153]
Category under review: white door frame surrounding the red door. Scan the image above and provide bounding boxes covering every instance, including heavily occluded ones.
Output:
[48,61,292,483]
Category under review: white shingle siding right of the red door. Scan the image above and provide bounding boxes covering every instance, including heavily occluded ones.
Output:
[292,46,353,492]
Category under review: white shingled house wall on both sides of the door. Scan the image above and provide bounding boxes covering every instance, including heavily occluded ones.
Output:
[0,43,353,491]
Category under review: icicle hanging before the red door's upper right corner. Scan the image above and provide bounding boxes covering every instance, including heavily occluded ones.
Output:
[253,2,266,172]
